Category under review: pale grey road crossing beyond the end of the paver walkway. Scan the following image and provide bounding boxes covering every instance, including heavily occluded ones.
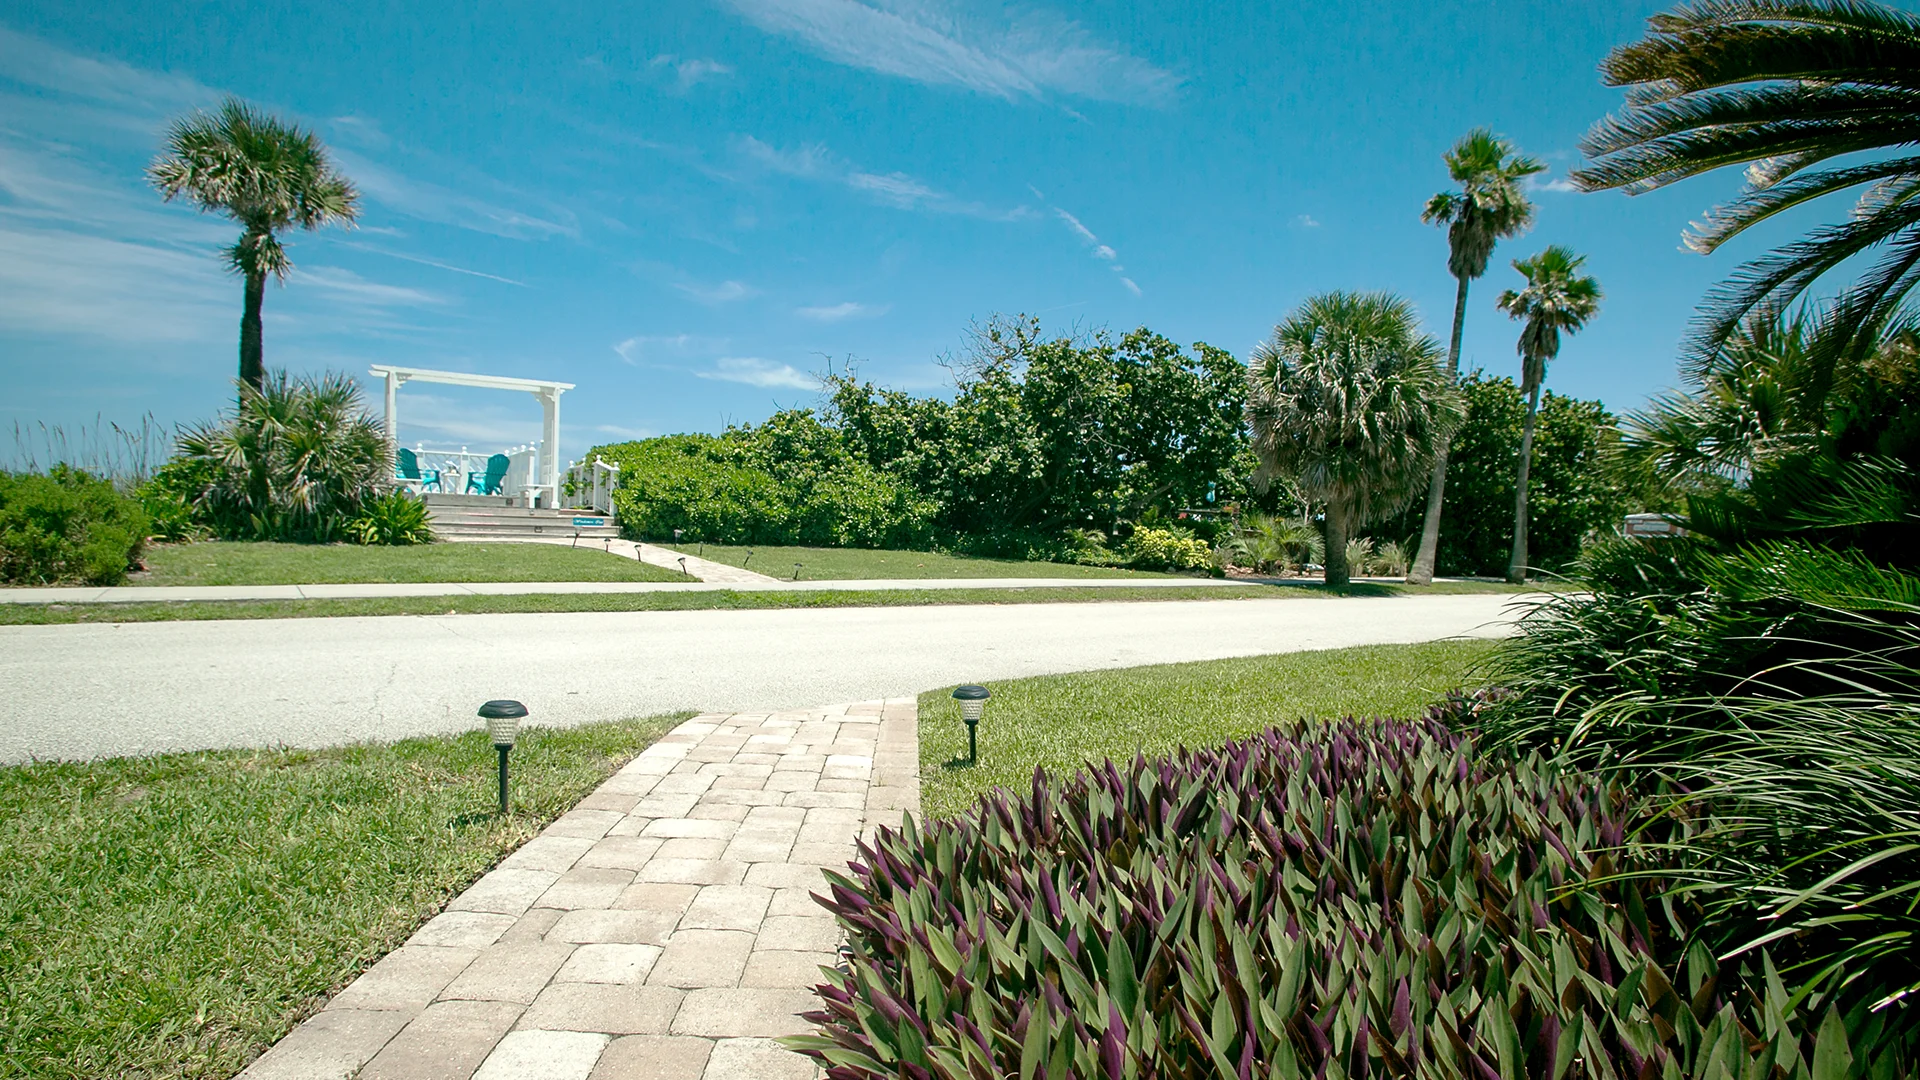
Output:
[0,594,1515,761]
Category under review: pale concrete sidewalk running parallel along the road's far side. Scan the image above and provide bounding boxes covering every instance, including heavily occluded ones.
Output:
[0,576,1284,603]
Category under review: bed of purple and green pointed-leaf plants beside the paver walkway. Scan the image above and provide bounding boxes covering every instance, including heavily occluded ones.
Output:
[789,714,1847,1080]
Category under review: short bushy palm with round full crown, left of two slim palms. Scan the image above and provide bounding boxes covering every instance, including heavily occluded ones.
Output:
[1246,292,1461,588]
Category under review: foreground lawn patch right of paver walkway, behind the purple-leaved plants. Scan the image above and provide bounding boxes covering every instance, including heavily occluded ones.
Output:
[920,640,1494,817]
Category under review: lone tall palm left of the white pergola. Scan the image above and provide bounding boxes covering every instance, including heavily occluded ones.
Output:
[146,98,359,390]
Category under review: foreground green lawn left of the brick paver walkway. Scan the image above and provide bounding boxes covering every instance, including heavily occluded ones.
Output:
[0,715,684,1080]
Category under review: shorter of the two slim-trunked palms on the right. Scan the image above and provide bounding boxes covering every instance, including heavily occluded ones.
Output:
[1500,244,1599,584]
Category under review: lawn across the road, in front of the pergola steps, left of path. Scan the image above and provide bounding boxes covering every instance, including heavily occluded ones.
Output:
[127,540,687,584]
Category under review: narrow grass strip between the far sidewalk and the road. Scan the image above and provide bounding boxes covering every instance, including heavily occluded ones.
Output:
[0,582,1519,626]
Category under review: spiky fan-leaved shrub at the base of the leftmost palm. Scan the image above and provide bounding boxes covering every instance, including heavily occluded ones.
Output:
[169,371,394,544]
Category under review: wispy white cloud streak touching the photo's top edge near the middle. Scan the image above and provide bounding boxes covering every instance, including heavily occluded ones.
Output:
[724,0,1181,104]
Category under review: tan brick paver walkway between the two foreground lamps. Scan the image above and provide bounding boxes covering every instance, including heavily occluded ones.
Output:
[240,698,920,1080]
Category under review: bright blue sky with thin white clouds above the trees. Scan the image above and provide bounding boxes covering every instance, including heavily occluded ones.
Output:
[0,0,1764,455]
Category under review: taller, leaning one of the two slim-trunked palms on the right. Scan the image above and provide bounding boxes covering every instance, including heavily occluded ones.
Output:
[1407,127,1546,584]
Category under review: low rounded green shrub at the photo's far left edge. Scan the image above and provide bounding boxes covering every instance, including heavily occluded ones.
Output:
[0,465,148,584]
